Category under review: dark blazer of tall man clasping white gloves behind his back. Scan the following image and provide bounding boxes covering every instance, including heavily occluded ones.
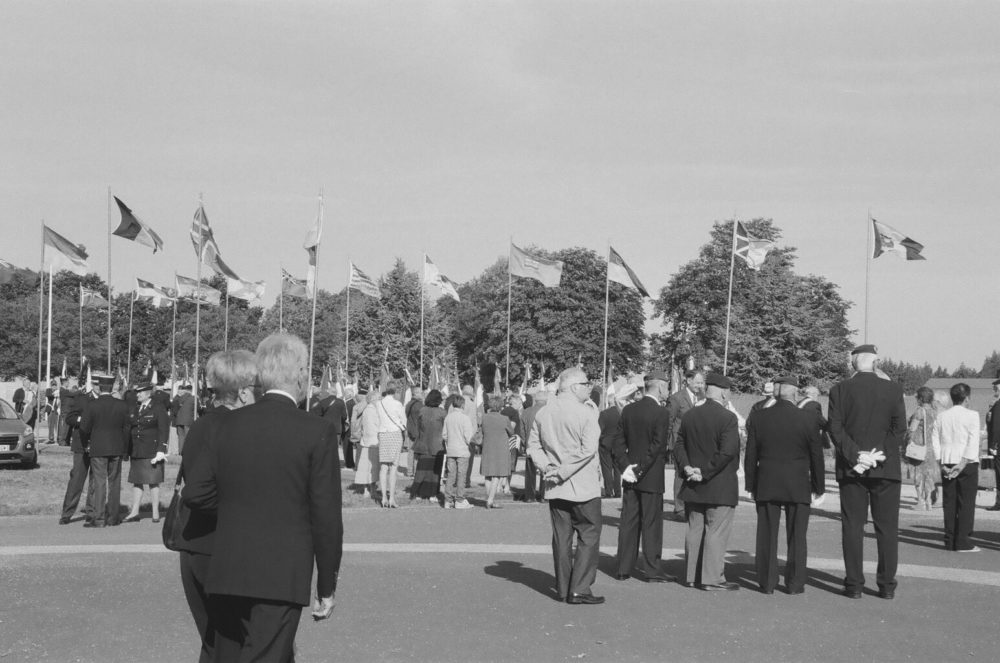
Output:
[829,373,906,481]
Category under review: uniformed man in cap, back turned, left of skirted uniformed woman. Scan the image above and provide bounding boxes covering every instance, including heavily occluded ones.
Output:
[80,375,130,527]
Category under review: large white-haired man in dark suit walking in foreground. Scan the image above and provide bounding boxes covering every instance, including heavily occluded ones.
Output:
[183,334,344,661]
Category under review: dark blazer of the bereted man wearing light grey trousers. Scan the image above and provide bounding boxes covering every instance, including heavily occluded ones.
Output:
[674,399,744,506]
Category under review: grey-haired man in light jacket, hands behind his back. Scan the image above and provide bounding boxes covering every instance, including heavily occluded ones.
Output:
[528,368,604,605]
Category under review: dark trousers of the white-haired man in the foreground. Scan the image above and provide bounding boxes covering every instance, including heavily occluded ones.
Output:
[209,594,302,663]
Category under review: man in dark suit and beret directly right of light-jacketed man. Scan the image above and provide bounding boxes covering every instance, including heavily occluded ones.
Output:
[611,371,676,582]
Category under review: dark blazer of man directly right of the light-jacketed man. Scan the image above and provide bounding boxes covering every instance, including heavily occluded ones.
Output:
[611,396,670,493]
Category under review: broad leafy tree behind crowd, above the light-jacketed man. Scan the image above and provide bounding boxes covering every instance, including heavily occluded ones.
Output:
[441,248,646,384]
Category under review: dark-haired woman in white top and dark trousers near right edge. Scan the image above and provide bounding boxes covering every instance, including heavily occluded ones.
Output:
[931,382,979,552]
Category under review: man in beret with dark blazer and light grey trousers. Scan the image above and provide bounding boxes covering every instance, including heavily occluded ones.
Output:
[674,373,740,591]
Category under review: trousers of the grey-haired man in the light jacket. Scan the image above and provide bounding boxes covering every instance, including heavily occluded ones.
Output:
[549,497,601,597]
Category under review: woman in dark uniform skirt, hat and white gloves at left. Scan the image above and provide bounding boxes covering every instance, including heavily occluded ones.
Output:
[124,382,170,523]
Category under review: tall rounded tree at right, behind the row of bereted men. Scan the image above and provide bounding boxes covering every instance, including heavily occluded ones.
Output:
[654,219,852,390]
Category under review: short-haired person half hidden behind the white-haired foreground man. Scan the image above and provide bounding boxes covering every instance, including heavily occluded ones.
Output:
[177,350,257,663]
